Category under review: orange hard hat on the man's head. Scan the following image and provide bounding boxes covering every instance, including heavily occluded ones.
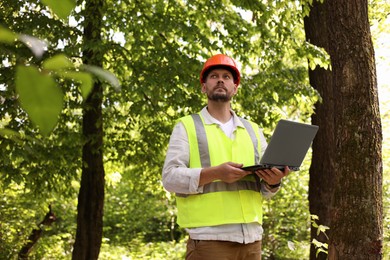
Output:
[200,54,240,86]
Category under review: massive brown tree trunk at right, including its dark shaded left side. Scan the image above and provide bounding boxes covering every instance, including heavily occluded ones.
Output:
[305,0,383,259]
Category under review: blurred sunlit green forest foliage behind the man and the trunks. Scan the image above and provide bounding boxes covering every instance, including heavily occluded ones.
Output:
[0,0,388,259]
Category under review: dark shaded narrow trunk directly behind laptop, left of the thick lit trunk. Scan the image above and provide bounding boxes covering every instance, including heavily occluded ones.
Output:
[305,2,336,259]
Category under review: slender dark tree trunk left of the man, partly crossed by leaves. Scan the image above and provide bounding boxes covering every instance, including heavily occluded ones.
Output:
[72,0,104,260]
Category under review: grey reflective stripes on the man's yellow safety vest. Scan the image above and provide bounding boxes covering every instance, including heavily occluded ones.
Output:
[176,114,260,198]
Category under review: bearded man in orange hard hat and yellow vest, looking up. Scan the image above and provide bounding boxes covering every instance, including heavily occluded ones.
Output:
[162,54,289,260]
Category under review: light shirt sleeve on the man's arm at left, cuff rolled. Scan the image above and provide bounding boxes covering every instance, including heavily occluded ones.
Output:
[162,122,203,194]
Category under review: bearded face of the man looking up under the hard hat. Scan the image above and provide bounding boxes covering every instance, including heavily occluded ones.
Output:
[202,69,238,102]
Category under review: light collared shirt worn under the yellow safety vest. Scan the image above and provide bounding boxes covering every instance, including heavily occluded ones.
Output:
[162,107,276,244]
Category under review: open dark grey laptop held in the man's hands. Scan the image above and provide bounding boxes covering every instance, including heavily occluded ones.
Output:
[242,119,318,172]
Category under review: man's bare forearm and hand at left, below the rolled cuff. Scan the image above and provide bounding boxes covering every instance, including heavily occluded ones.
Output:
[199,162,251,186]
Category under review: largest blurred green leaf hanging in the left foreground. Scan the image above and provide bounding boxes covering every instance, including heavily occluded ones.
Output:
[16,66,63,136]
